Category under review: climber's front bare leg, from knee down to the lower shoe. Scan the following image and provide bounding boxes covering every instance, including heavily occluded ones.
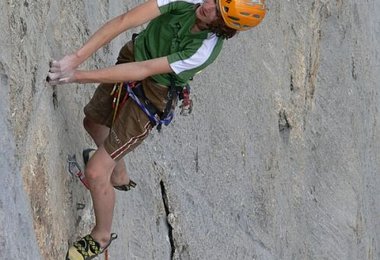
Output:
[85,146,116,247]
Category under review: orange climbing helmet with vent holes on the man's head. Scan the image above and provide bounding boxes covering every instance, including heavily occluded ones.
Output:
[218,0,266,31]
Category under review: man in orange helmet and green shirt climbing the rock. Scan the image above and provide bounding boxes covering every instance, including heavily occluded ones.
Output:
[47,0,266,260]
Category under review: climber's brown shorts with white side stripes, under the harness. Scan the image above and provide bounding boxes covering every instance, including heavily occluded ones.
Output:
[84,41,172,160]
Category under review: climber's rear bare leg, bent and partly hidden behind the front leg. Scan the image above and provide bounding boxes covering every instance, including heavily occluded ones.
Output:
[83,117,129,186]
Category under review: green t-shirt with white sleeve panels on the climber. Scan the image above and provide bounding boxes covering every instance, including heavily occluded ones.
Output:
[134,0,223,86]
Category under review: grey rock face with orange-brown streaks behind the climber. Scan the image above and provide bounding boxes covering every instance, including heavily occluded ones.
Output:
[0,0,380,260]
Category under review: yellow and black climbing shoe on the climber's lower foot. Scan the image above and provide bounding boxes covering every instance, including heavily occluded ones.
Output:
[66,233,117,260]
